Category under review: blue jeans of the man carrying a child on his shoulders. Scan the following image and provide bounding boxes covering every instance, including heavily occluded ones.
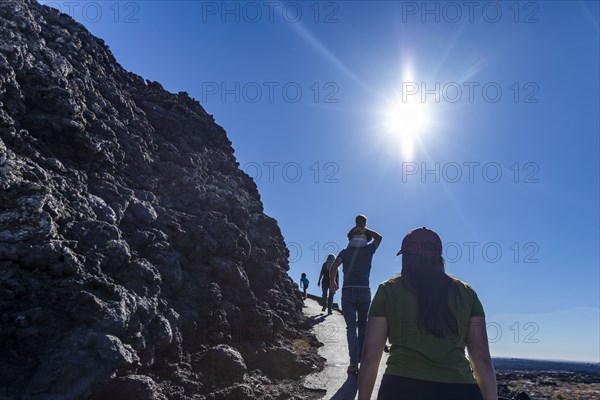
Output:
[342,288,371,365]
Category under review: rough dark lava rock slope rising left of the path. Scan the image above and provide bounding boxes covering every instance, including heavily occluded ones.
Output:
[0,0,323,400]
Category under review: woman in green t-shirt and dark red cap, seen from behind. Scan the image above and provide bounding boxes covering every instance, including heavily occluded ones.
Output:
[358,228,498,400]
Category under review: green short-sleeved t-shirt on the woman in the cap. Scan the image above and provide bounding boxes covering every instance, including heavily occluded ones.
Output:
[369,276,485,383]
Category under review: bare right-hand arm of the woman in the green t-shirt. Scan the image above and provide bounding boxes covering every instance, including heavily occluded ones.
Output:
[467,317,498,400]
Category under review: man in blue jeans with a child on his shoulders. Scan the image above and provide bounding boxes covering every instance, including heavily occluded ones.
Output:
[329,215,382,374]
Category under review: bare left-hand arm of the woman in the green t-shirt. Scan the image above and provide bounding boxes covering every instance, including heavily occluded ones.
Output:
[358,317,388,400]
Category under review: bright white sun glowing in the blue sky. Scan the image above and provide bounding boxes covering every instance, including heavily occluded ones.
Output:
[385,99,429,160]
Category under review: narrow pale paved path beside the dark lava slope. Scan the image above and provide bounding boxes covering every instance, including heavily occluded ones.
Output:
[304,298,387,400]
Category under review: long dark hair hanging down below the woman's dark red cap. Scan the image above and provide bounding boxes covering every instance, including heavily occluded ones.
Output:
[401,254,458,338]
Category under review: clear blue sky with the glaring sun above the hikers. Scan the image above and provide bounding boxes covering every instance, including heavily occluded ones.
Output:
[43,1,600,362]
